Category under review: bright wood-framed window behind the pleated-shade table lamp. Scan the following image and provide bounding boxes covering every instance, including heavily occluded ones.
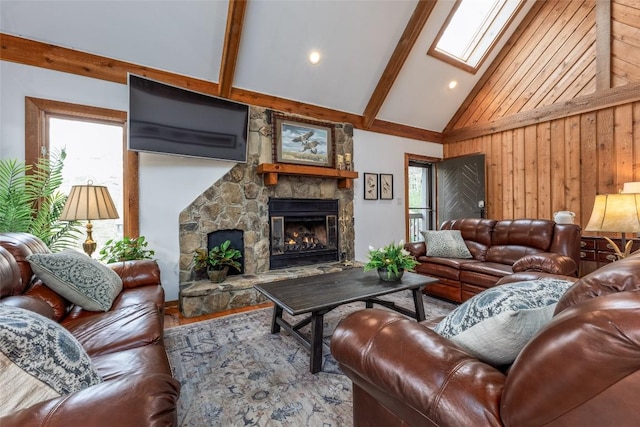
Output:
[25,98,139,244]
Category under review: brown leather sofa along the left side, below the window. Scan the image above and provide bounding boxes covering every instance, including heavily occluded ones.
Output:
[0,233,180,427]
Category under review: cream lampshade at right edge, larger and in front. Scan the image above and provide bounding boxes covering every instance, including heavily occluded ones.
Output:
[585,193,640,233]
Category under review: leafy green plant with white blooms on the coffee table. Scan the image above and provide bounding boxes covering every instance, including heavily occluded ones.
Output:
[364,240,419,281]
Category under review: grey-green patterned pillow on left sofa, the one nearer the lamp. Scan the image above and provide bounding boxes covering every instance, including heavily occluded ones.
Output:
[27,250,122,311]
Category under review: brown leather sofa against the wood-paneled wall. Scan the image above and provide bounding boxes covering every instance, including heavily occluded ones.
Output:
[405,218,581,302]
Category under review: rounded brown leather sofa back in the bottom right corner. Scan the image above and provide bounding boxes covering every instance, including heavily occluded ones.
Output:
[501,291,640,426]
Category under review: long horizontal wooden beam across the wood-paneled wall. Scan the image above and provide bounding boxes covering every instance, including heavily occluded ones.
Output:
[442,83,640,144]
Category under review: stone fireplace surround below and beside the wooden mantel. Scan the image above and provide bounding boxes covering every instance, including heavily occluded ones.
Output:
[179,107,355,315]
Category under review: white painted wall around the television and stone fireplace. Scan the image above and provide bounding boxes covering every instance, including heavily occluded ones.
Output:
[0,61,442,301]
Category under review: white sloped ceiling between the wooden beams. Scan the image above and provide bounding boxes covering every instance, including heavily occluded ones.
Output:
[0,0,533,132]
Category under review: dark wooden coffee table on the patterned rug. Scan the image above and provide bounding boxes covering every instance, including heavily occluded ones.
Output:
[254,268,438,374]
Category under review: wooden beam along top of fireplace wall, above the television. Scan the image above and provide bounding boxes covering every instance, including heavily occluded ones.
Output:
[0,33,442,142]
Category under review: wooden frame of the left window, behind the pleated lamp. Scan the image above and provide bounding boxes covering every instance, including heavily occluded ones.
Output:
[25,97,140,237]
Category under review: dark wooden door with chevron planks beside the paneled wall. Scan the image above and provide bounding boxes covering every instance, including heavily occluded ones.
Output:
[436,154,486,224]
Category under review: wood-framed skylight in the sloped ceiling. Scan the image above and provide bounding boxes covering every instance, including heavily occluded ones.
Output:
[428,0,524,73]
